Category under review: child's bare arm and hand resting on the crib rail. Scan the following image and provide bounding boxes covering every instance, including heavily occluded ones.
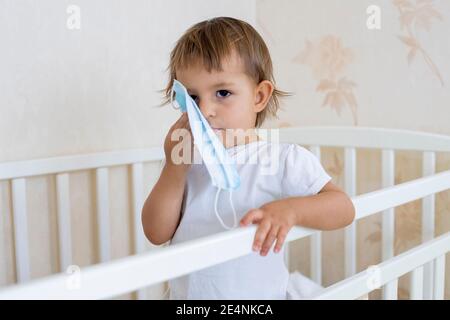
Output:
[241,182,355,255]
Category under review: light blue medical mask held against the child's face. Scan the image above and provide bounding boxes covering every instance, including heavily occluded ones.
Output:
[170,79,241,229]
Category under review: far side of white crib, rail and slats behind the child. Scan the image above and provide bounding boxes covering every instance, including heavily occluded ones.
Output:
[0,127,450,298]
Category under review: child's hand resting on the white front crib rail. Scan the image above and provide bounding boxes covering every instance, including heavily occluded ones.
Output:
[240,200,296,256]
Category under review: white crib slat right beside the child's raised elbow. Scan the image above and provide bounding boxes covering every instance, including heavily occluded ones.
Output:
[131,163,146,300]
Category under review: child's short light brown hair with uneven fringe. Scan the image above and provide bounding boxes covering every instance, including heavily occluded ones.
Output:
[160,17,290,127]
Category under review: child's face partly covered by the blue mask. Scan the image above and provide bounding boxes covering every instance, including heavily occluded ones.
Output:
[176,53,273,147]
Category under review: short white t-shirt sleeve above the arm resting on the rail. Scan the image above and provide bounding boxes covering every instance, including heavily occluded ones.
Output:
[281,144,331,197]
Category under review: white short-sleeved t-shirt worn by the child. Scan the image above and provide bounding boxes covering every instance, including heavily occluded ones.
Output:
[169,141,331,299]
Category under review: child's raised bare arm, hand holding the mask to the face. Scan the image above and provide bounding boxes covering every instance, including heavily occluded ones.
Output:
[142,113,193,245]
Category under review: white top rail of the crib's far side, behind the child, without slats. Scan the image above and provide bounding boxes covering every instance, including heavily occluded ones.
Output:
[0,126,450,180]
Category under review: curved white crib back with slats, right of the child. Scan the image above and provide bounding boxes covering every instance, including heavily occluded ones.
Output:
[274,126,450,290]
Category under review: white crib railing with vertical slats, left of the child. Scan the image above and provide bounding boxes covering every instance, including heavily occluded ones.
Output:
[0,147,164,299]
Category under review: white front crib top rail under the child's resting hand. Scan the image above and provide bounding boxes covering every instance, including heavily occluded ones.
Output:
[0,170,450,299]
